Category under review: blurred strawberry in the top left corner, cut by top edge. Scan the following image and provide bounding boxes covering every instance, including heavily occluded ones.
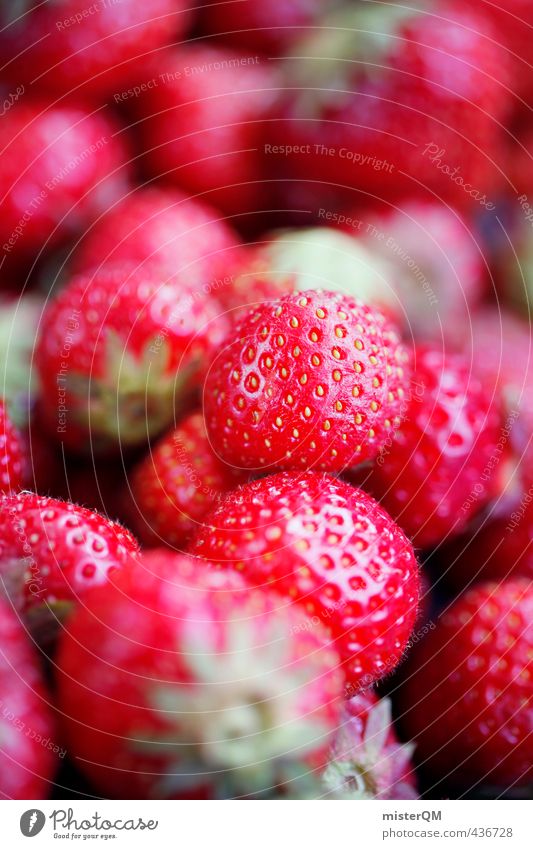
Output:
[0,0,190,97]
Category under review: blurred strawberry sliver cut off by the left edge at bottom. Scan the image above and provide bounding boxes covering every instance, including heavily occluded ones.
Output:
[0,602,57,799]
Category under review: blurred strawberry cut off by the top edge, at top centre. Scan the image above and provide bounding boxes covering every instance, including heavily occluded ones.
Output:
[200,0,328,53]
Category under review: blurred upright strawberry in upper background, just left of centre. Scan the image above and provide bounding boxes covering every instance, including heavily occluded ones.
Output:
[133,42,280,215]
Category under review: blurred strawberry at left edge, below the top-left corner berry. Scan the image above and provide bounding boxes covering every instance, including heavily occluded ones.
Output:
[0,102,129,274]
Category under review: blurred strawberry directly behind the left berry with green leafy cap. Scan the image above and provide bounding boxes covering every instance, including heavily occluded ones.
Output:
[72,188,238,295]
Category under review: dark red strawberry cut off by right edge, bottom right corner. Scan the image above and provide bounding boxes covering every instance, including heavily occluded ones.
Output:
[400,580,533,789]
